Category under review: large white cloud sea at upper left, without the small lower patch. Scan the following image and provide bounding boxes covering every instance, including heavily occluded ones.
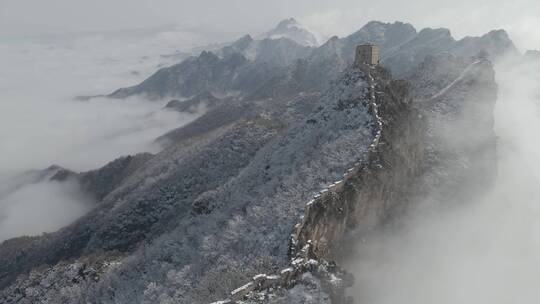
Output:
[0,32,200,175]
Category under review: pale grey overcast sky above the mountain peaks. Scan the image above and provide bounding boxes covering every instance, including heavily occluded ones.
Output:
[0,0,540,49]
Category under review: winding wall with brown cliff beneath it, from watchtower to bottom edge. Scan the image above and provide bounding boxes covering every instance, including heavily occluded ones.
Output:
[213,44,423,304]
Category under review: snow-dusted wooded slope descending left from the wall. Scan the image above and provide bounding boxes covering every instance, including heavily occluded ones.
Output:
[2,64,377,303]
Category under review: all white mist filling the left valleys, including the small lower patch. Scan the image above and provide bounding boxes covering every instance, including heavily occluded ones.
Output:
[0,28,207,241]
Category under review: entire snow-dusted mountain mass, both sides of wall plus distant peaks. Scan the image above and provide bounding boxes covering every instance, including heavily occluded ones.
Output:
[0,22,506,303]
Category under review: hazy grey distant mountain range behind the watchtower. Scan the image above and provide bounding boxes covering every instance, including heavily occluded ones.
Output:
[110,19,518,99]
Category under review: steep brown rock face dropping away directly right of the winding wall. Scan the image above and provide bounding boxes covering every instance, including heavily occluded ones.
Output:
[291,68,425,260]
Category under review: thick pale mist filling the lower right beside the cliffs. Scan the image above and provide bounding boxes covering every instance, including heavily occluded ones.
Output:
[346,56,540,304]
